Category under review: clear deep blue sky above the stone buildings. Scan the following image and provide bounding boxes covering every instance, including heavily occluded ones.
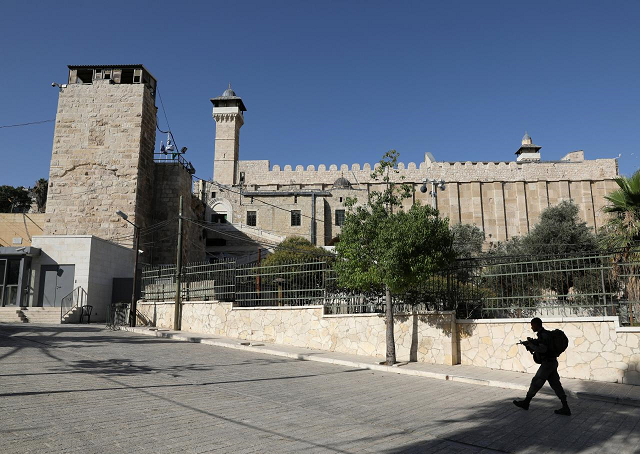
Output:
[0,0,640,186]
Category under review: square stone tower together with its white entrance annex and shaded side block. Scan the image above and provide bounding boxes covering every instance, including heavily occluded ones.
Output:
[0,65,205,320]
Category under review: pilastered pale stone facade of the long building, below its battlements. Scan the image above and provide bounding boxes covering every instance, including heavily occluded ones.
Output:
[202,176,617,246]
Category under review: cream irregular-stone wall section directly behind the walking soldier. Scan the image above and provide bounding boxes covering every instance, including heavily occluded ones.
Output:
[457,317,640,385]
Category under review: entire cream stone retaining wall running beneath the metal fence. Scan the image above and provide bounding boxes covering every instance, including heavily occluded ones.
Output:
[138,302,640,385]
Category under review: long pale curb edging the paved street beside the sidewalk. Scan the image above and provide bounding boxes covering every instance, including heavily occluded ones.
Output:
[121,326,640,407]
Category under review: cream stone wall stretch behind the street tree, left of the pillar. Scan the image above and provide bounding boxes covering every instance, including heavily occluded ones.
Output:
[138,302,458,364]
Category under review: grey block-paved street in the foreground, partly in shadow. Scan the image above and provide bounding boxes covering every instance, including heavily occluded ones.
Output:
[0,324,640,454]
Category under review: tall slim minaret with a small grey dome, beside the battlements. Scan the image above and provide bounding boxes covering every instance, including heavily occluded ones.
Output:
[211,84,247,185]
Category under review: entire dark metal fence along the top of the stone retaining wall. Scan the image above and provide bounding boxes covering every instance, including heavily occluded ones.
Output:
[142,254,640,325]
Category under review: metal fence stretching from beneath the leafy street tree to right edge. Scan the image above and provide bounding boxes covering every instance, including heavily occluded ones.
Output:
[325,254,640,325]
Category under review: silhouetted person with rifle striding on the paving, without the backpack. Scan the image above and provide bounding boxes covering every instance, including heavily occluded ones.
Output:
[513,317,571,416]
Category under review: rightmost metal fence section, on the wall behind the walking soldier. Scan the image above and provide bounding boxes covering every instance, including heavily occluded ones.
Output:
[447,254,640,324]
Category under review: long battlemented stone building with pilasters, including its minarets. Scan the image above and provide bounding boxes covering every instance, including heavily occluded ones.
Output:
[195,88,618,256]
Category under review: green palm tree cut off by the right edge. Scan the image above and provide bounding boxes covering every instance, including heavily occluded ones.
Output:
[602,170,640,324]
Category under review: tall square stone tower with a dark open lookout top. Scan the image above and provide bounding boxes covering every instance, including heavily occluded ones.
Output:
[44,65,157,244]
